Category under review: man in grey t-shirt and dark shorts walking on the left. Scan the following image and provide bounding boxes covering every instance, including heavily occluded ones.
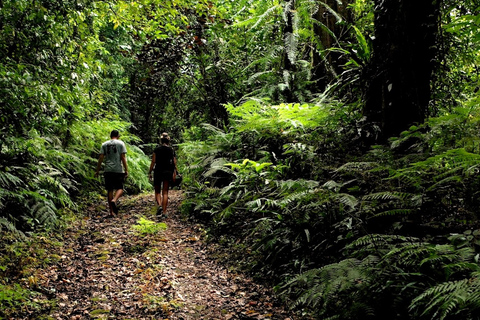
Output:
[95,130,128,217]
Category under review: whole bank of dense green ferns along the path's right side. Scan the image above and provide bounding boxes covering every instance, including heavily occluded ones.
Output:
[181,100,480,319]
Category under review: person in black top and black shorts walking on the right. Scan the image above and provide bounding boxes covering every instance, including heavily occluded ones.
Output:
[148,132,177,218]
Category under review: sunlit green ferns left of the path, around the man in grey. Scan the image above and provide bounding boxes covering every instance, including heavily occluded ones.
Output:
[0,119,151,237]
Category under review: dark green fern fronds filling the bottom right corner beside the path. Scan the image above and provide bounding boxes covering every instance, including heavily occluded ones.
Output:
[281,235,480,319]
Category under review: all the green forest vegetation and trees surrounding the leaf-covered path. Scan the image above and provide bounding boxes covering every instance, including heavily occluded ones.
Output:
[0,0,480,319]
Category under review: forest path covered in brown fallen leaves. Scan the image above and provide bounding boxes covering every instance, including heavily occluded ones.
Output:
[42,190,293,320]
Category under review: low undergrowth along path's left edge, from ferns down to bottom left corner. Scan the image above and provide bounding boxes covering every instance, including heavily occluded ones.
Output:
[0,119,151,318]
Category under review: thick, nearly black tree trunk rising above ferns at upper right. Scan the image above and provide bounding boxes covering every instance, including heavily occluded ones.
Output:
[364,0,439,141]
